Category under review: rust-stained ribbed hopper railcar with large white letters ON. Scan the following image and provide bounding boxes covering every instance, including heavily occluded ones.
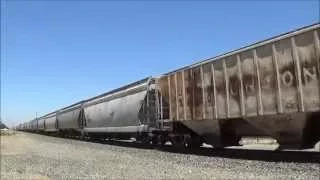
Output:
[157,24,320,147]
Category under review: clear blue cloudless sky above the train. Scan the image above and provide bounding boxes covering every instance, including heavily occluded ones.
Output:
[1,0,319,125]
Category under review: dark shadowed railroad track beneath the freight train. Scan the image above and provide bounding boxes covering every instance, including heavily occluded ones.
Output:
[40,133,320,164]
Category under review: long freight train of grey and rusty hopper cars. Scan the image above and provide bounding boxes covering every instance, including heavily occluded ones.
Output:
[16,23,320,149]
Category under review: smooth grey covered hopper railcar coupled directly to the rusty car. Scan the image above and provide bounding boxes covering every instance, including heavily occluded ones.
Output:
[82,78,152,139]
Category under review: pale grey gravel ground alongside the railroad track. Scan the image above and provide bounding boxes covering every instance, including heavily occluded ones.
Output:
[1,132,320,180]
